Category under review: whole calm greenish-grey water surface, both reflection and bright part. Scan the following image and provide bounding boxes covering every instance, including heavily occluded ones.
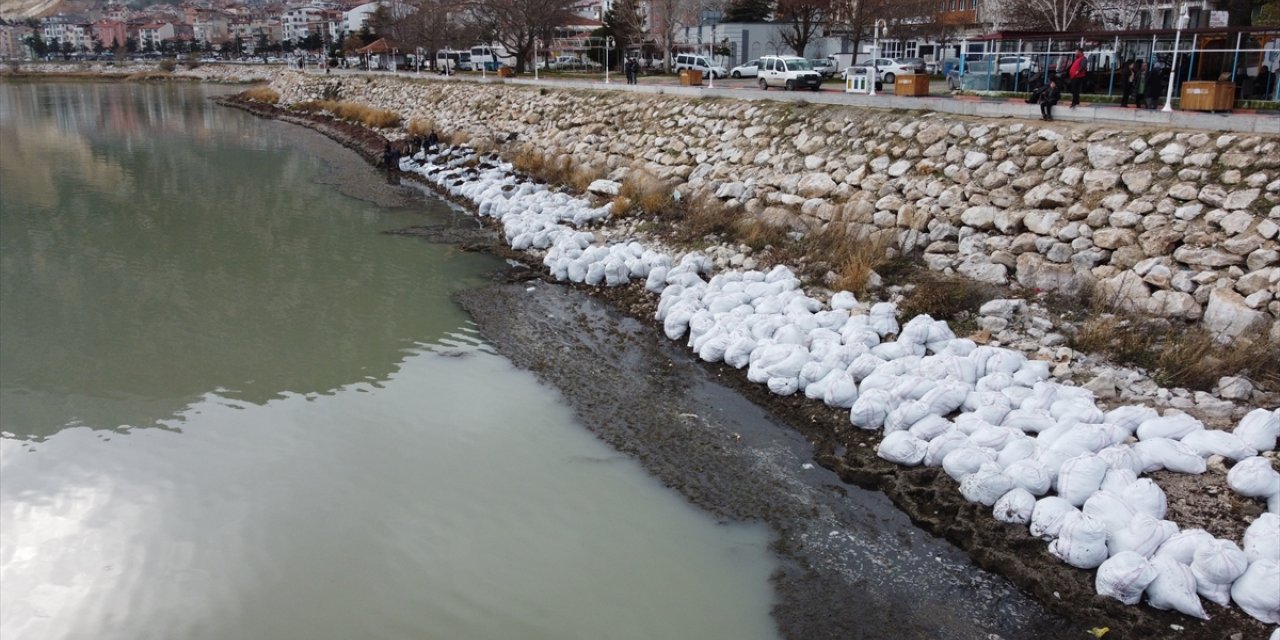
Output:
[0,83,776,640]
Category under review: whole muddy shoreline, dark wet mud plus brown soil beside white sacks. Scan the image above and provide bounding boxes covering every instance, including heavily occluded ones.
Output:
[219,99,1267,639]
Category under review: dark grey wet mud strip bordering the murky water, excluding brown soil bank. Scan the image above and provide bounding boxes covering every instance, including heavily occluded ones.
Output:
[457,280,1083,639]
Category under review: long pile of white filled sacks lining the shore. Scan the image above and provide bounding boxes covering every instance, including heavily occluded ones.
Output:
[401,147,1280,623]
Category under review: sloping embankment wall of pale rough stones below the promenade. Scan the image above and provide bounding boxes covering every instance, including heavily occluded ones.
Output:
[274,73,1280,342]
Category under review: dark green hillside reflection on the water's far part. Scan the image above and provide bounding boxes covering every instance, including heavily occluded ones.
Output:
[0,84,499,436]
